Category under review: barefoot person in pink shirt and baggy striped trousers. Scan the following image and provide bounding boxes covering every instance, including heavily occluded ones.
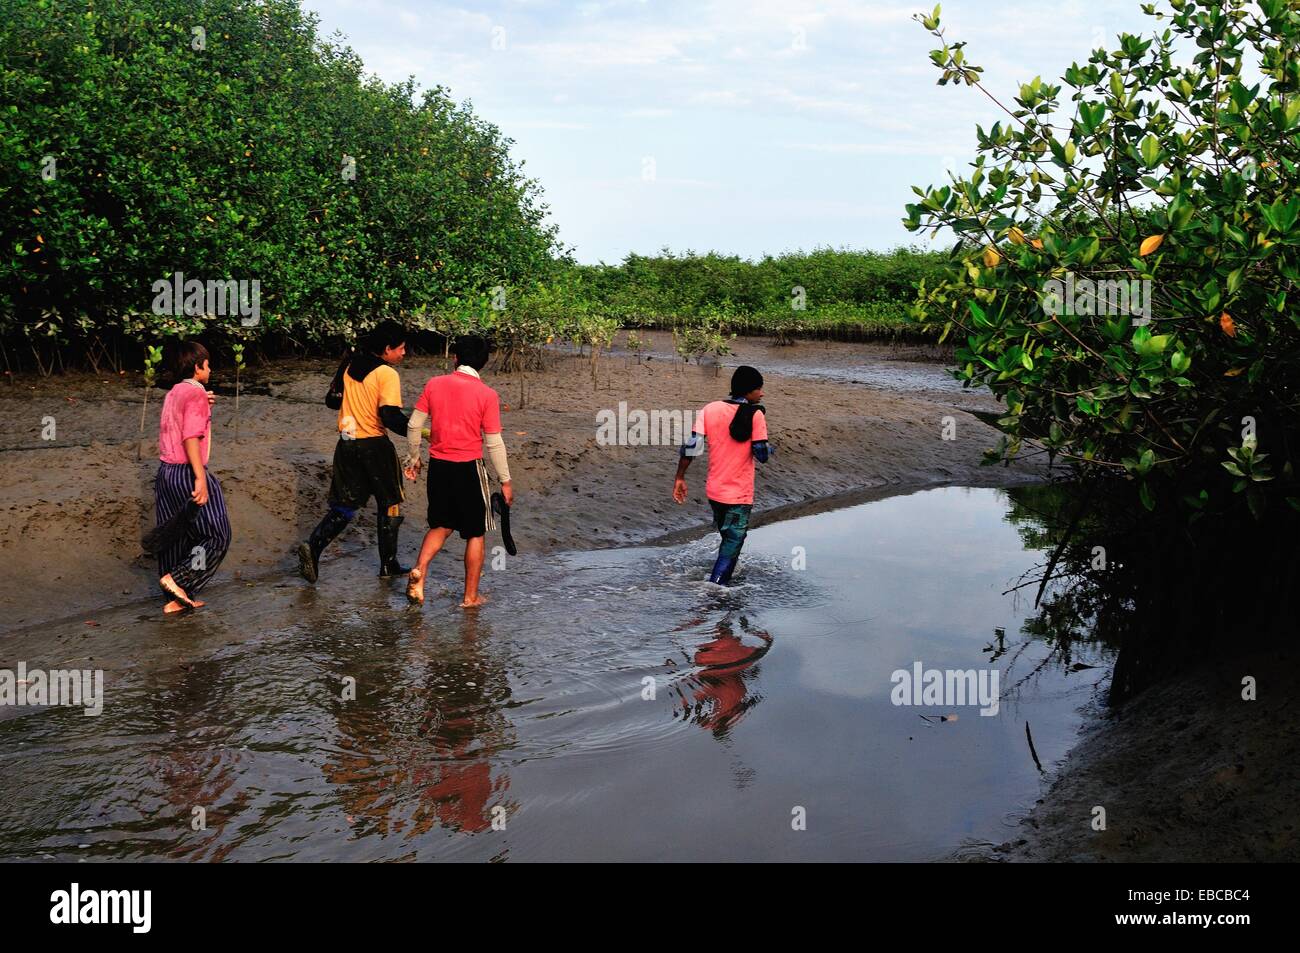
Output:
[153,341,230,612]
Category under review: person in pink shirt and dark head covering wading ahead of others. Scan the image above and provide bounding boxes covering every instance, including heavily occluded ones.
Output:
[672,365,772,585]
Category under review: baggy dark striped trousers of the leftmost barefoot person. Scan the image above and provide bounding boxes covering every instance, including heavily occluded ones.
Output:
[153,463,230,598]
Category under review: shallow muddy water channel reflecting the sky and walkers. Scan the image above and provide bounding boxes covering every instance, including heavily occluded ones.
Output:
[0,488,1100,861]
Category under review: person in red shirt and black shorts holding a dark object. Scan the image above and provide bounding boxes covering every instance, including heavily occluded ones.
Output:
[404,335,515,608]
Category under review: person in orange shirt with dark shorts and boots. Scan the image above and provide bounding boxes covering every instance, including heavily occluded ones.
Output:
[298,321,410,582]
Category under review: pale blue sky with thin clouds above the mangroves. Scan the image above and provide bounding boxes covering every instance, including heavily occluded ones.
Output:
[303,0,1156,264]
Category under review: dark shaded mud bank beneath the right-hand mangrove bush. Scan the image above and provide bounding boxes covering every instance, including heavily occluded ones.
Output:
[982,650,1300,863]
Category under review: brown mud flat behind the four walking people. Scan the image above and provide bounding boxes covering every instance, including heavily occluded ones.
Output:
[0,332,1041,632]
